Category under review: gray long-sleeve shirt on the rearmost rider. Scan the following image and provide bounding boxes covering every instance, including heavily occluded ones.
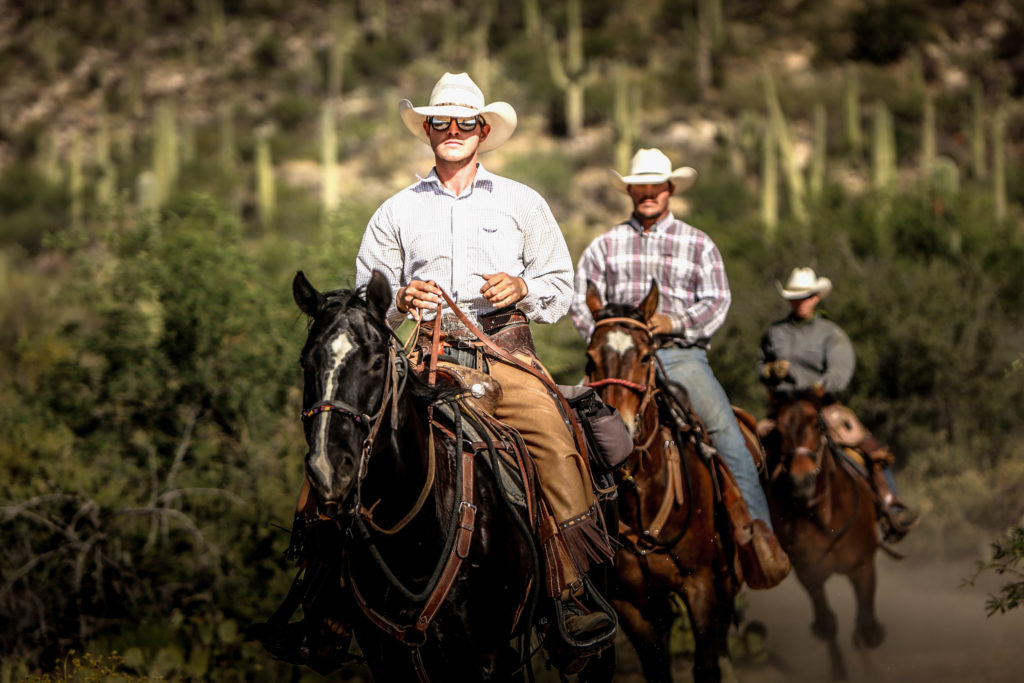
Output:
[758,314,856,395]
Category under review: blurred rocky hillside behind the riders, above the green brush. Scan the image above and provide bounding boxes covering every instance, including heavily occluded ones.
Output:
[0,0,1024,245]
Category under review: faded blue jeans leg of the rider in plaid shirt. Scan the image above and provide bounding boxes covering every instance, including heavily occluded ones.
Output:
[657,348,772,527]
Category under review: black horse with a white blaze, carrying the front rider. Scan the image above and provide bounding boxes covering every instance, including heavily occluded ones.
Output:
[293,272,543,681]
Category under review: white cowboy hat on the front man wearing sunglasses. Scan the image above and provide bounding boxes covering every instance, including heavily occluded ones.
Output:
[398,72,518,153]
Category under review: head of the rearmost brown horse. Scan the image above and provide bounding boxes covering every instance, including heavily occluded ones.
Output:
[769,399,826,508]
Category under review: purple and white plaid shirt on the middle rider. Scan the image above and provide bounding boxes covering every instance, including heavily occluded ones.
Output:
[569,213,732,349]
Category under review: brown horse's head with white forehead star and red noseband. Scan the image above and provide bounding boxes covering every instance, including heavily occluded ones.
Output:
[587,281,658,437]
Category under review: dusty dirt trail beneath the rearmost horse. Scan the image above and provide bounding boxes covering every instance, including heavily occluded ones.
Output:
[733,556,1024,683]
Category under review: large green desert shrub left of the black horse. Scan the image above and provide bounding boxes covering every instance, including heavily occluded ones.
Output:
[0,200,303,663]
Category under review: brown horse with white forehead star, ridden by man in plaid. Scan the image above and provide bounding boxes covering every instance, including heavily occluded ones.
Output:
[581,287,739,682]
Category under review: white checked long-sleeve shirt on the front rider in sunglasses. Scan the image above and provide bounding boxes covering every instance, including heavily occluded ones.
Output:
[355,164,572,327]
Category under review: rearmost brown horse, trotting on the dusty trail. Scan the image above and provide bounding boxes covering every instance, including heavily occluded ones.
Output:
[764,397,885,681]
